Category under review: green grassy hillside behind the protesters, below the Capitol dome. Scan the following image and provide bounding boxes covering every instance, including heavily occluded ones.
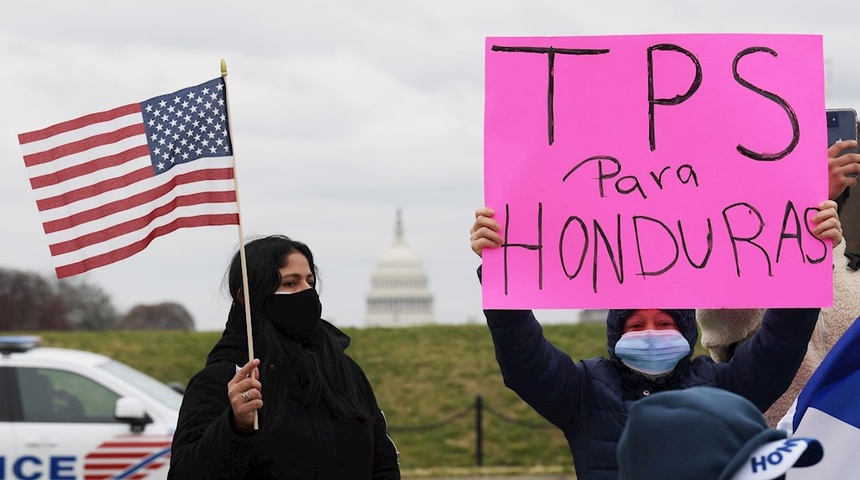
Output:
[21,324,702,476]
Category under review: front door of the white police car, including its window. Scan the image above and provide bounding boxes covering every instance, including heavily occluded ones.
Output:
[7,367,166,479]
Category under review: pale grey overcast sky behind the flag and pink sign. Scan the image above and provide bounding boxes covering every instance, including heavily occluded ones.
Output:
[0,0,860,330]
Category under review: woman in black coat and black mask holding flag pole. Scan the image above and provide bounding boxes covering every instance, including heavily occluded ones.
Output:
[169,236,400,479]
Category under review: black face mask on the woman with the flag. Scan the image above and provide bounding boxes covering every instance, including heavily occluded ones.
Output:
[263,288,322,345]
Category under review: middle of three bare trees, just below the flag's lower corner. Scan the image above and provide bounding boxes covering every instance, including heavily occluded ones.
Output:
[57,278,119,330]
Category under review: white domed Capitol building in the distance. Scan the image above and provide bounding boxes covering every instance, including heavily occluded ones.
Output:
[365,209,436,327]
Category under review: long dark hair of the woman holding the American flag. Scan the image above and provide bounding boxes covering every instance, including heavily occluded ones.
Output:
[227,235,373,425]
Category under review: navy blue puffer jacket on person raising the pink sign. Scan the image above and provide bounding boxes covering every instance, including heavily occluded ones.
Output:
[484,308,819,480]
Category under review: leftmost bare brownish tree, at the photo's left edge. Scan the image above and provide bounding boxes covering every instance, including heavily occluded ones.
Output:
[0,268,71,331]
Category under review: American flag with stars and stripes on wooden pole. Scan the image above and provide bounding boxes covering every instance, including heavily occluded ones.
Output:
[18,77,239,278]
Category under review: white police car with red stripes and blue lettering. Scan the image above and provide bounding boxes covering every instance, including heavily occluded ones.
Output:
[0,337,182,480]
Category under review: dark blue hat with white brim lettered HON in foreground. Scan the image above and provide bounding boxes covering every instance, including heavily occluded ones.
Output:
[618,387,824,480]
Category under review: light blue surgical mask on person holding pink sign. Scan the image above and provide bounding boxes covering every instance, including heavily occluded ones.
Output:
[615,330,690,375]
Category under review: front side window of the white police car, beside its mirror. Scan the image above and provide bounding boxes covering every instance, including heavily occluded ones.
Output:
[16,368,119,423]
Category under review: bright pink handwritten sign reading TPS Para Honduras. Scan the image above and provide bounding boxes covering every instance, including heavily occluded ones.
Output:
[483,34,832,309]
